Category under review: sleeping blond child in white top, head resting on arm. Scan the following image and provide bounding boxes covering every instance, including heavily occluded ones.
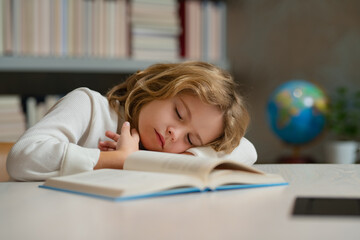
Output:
[7,62,257,181]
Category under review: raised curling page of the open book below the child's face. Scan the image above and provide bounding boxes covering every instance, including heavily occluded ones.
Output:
[124,151,216,179]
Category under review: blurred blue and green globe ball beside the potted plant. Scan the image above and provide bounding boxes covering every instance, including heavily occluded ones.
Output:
[267,80,327,145]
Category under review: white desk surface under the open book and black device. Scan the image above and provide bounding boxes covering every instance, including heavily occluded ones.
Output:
[0,164,360,240]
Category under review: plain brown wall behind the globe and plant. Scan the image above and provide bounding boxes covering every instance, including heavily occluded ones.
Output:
[227,0,360,163]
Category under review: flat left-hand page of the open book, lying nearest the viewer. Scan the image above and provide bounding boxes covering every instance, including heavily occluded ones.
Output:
[44,169,203,197]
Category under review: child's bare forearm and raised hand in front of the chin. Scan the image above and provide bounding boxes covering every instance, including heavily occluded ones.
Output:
[94,122,140,169]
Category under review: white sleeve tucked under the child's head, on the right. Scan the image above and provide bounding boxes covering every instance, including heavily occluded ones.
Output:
[187,138,257,165]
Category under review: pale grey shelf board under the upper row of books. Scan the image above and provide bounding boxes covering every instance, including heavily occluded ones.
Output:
[0,56,229,73]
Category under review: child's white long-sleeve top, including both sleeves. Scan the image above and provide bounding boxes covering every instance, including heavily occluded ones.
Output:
[7,88,257,181]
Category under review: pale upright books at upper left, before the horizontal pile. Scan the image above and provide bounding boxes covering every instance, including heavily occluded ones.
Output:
[0,0,129,58]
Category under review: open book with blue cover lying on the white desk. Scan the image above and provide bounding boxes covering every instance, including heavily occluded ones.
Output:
[40,151,287,201]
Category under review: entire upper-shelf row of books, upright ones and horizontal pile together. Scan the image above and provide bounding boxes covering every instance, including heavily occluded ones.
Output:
[0,0,226,62]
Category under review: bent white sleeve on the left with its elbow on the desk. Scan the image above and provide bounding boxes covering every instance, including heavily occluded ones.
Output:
[7,89,100,181]
